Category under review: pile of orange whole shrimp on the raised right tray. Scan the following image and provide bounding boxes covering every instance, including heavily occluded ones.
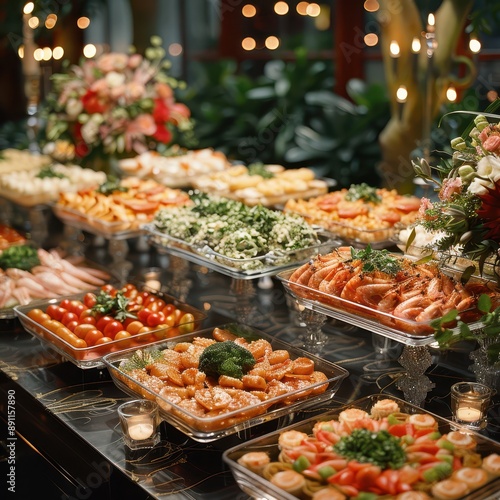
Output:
[290,247,498,333]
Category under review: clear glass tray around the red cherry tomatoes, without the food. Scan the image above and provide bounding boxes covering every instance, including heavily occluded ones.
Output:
[14,286,206,369]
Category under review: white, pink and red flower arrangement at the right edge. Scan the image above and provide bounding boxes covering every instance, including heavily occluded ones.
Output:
[406,109,500,276]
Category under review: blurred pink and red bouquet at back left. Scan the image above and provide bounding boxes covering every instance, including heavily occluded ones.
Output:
[40,36,192,166]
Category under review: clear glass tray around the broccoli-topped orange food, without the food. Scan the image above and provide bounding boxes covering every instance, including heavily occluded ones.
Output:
[104,323,348,442]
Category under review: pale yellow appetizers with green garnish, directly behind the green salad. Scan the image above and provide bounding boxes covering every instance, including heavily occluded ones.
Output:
[189,163,333,207]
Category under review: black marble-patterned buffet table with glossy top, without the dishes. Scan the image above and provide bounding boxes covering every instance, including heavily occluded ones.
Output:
[0,224,500,500]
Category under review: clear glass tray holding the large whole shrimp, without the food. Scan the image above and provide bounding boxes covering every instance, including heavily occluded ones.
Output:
[276,269,488,346]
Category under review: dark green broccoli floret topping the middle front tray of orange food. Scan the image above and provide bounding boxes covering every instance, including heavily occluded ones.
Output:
[198,340,255,379]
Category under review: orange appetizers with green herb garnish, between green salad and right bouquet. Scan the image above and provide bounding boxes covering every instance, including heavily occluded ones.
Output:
[284,183,420,248]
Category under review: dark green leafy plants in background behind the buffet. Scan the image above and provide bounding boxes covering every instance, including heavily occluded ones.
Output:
[179,52,390,187]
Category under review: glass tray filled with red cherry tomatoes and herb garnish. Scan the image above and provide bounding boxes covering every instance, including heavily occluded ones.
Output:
[14,282,206,369]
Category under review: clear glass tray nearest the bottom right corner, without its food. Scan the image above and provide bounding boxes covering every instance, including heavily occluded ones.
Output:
[222,394,500,500]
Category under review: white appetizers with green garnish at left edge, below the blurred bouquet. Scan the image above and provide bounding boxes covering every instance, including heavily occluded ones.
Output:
[0,163,106,207]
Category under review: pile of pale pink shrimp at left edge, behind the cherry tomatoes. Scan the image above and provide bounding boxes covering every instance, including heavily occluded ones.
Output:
[0,249,110,309]
